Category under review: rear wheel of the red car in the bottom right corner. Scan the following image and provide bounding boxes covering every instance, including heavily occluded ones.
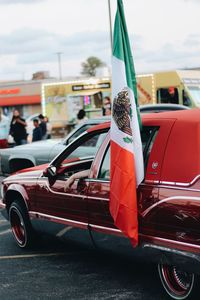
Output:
[158,264,199,300]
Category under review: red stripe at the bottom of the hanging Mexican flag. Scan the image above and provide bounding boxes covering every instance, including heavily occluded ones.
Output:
[110,140,138,247]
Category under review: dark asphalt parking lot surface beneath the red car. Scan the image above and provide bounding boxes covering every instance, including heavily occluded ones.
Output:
[0,176,167,300]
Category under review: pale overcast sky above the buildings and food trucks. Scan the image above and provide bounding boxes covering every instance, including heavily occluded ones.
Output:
[0,0,200,80]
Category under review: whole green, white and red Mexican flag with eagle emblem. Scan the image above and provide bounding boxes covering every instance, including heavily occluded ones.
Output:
[110,0,144,246]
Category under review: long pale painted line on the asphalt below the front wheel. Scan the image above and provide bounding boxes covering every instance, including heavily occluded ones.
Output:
[0,251,87,260]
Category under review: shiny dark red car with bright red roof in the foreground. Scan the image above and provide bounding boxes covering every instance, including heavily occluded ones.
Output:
[0,109,200,299]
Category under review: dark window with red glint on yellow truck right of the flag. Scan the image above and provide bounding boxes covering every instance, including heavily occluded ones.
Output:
[157,87,179,104]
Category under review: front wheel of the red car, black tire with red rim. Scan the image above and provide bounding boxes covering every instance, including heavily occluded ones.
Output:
[9,201,34,248]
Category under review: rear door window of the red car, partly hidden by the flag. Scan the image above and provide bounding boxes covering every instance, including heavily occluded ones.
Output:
[98,126,159,180]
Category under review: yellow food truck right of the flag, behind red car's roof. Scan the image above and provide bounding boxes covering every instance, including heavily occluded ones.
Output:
[137,70,200,107]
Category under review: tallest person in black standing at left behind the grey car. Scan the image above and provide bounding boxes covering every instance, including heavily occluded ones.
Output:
[10,109,27,146]
